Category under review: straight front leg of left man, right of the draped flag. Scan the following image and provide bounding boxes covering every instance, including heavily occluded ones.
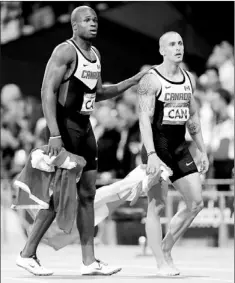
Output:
[77,170,97,265]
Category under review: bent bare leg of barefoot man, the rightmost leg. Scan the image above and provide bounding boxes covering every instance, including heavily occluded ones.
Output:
[162,173,203,267]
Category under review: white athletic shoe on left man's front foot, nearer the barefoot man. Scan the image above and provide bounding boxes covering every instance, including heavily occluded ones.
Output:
[80,260,122,275]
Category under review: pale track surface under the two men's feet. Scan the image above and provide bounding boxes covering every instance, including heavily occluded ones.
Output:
[1,242,234,283]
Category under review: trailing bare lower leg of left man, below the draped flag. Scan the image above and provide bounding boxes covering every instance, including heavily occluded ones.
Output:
[21,198,56,258]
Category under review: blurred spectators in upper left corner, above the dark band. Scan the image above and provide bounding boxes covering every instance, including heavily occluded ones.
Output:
[1,1,119,43]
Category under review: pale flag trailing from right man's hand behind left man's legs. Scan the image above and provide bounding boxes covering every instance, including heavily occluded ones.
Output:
[17,165,171,250]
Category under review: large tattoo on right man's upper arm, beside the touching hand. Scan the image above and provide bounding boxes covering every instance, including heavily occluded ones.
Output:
[138,75,155,115]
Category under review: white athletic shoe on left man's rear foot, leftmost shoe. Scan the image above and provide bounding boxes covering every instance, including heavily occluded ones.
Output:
[16,254,53,276]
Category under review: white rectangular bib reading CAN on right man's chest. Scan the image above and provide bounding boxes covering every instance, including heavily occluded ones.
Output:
[162,107,189,125]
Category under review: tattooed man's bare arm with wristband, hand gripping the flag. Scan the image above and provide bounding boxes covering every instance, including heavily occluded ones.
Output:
[137,73,161,174]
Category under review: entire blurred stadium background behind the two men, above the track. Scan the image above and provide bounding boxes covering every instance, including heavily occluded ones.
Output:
[0,1,234,251]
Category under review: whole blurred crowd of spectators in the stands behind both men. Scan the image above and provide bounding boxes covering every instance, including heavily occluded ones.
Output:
[0,1,234,251]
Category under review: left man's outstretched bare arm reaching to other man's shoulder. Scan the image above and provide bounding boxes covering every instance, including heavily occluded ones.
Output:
[93,49,150,101]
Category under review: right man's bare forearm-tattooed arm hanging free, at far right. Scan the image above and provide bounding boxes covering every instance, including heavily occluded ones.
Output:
[186,74,209,173]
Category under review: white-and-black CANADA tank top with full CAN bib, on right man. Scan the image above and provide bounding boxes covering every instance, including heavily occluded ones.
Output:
[150,67,193,150]
